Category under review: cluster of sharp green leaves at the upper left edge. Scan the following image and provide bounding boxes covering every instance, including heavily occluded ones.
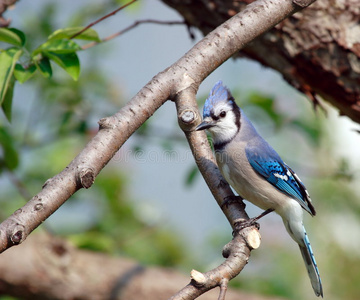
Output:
[0,27,100,121]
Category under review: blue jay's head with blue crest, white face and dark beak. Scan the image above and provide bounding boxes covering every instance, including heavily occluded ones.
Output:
[195,81,240,142]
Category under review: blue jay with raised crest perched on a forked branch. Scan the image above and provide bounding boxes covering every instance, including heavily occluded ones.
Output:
[195,81,323,296]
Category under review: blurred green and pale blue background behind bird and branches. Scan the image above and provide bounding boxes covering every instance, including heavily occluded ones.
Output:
[0,0,360,299]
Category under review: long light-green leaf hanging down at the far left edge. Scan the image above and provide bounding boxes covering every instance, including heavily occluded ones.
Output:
[0,48,22,105]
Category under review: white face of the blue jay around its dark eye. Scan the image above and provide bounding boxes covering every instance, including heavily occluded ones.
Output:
[205,102,238,143]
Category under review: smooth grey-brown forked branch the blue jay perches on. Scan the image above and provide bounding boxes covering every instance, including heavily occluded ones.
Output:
[0,0,314,299]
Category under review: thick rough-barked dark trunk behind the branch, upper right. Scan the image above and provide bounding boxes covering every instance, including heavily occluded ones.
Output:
[162,0,360,123]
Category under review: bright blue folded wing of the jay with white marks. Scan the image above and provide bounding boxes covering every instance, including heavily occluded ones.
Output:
[245,140,316,215]
